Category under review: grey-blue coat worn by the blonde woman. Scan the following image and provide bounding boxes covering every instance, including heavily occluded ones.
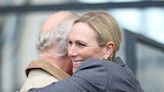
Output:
[29,57,143,92]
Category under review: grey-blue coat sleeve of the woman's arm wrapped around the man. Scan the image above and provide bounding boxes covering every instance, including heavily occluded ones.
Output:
[28,58,107,92]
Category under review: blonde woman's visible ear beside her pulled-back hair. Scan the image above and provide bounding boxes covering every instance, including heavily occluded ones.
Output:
[104,41,115,58]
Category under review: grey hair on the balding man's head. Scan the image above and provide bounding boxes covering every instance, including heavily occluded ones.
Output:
[37,12,77,57]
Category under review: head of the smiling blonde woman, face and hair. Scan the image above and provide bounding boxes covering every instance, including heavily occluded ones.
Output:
[68,12,121,70]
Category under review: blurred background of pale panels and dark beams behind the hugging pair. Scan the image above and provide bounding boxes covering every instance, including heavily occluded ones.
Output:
[0,0,164,92]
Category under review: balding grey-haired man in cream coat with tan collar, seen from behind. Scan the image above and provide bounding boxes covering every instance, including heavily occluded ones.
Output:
[21,11,77,92]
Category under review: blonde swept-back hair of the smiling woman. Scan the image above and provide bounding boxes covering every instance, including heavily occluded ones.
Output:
[75,11,121,58]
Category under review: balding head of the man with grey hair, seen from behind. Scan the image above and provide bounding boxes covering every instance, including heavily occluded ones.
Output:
[37,11,78,56]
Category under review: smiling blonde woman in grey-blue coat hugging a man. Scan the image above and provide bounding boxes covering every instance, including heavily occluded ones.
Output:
[30,12,143,92]
